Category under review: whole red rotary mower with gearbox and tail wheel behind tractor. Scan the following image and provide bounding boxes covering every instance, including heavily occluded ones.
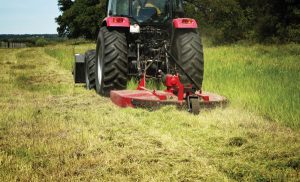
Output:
[110,74,227,114]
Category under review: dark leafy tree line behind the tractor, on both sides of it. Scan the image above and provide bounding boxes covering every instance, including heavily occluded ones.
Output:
[56,0,300,43]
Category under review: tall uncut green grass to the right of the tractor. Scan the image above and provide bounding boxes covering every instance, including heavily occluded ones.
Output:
[204,44,300,128]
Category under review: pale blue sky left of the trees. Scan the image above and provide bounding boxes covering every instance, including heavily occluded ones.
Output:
[0,0,60,34]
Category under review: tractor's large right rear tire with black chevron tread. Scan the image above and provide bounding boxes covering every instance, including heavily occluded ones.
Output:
[171,30,204,90]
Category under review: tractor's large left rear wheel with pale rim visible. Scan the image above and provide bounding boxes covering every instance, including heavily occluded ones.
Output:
[95,27,128,96]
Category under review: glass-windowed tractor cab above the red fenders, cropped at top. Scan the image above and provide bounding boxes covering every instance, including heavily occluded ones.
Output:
[107,0,183,24]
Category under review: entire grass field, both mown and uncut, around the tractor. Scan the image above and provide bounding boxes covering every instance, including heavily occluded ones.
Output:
[0,44,300,181]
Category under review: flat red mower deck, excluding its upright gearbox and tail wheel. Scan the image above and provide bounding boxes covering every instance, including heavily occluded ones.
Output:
[110,90,227,108]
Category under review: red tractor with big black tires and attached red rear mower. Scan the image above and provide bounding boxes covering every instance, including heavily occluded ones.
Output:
[75,0,226,114]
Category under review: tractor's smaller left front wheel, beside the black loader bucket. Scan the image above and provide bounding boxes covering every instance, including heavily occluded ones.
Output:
[85,50,96,90]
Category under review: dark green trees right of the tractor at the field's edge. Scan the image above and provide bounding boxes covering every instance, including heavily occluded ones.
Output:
[185,0,300,43]
